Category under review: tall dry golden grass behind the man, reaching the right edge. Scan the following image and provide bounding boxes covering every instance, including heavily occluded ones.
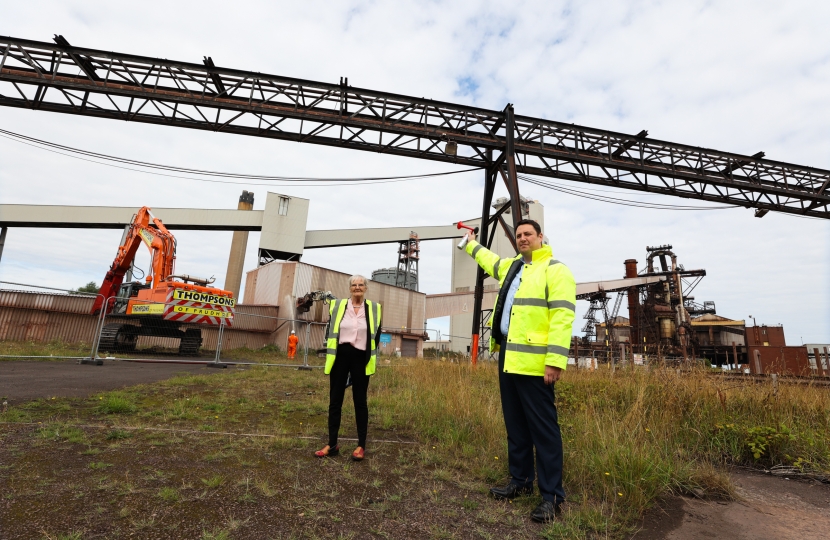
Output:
[370,362,830,537]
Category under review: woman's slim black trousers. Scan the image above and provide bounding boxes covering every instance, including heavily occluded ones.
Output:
[329,343,369,448]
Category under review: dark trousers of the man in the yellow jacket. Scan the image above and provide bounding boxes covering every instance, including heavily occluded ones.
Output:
[499,343,565,504]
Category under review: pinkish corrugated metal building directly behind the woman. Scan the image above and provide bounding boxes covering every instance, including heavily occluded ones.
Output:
[244,261,426,357]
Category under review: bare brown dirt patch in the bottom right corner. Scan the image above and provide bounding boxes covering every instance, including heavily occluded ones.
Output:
[633,471,830,540]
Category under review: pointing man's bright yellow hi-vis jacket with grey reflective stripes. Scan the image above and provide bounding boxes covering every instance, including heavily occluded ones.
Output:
[466,240,576,375]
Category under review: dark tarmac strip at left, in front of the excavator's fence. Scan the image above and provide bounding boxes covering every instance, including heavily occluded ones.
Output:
[0,360,226,403]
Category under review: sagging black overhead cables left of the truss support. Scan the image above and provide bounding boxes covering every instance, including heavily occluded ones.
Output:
[0,129,478,187]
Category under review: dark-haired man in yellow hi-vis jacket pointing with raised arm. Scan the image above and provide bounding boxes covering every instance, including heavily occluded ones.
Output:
[466,219,576,522]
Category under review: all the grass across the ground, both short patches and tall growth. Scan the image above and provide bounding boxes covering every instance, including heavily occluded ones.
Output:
[0,360,830,538]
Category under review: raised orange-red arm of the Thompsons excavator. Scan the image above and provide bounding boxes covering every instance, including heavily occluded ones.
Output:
[92,206,176,315]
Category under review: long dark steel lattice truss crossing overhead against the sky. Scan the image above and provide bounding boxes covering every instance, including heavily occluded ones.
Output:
[0,36,830,218]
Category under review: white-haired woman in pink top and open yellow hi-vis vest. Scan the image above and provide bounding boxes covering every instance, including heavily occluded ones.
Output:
[314,275,381,461]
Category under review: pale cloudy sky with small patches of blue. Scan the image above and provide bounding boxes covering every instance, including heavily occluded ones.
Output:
[0,0,830,344]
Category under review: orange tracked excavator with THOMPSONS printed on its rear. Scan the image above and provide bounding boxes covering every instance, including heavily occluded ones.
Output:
[92,206,236,356]
